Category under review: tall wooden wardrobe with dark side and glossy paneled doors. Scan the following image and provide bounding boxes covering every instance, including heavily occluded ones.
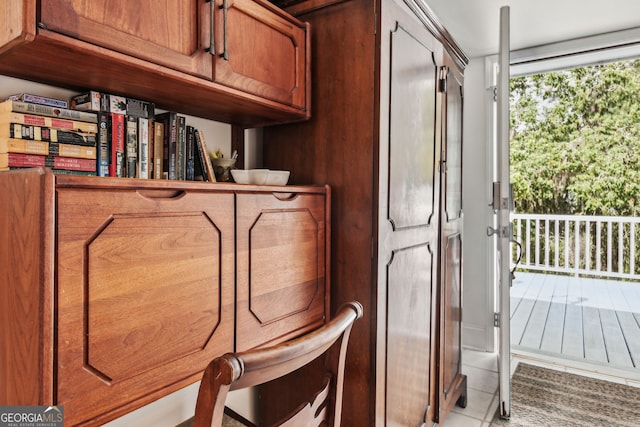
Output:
[264,0,467,426]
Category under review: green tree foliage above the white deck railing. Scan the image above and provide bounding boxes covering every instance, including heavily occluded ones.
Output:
[511,60,640,216]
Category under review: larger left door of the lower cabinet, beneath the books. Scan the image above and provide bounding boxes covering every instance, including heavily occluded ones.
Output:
[56,188,234,425]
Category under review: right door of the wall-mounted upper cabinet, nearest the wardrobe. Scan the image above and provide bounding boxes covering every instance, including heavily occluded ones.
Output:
[214,0,310,109]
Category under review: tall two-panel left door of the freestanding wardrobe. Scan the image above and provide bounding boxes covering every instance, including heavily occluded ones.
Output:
[378,2,441,426]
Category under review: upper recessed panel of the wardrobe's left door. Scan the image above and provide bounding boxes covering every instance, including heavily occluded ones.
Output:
[388,26,436,229]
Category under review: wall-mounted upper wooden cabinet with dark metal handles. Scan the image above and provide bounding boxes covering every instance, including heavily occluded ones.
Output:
[0,0,311,127]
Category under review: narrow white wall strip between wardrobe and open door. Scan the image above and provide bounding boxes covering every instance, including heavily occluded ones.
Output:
[462,58,494,351]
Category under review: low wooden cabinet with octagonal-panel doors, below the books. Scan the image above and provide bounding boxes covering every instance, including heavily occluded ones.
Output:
[0,169,329,425]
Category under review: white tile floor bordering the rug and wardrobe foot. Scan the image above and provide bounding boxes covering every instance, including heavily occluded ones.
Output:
[441,349,640,427]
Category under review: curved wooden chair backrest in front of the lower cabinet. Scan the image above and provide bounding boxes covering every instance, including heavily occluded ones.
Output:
[193,301,363,427]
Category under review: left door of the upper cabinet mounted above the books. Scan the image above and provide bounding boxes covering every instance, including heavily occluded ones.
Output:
[40,0,213,79]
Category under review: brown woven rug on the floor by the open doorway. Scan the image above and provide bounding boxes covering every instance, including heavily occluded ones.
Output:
[491,362,640,427]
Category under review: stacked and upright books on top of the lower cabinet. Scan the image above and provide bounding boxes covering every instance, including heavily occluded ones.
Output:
[0,91,215,181]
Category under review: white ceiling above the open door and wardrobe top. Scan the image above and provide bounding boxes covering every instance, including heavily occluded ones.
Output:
[424,0,640,58]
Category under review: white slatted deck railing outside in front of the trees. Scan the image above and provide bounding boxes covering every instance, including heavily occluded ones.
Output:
[512,213,640,280]
